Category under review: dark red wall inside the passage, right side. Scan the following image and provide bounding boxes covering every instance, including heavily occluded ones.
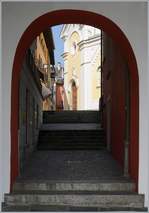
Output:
[103,33,125,166]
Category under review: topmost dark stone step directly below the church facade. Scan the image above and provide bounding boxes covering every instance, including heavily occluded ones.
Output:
[43,110,101,123]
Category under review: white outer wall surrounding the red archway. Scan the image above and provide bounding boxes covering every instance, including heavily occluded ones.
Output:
[0,1,149,210]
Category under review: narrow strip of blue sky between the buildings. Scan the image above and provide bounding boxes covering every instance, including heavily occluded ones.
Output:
[52,25,64,64]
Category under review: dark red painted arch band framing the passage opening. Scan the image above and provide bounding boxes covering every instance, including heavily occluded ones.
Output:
[11,10,139,191]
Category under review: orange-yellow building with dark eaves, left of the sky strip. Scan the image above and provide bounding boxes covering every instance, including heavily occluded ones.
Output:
[32,29,55,110]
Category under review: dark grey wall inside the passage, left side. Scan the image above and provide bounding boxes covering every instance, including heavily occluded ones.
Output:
[19,59,42,172]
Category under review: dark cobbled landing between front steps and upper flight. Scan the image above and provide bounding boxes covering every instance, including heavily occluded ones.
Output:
[18,150,123,181]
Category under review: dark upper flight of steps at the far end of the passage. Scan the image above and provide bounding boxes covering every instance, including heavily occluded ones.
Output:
[37,111,105,150]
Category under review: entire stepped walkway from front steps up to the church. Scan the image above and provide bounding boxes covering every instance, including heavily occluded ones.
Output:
[2,111,147,212]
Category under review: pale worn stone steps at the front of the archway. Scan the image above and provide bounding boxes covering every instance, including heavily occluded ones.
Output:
[3,181,147,211]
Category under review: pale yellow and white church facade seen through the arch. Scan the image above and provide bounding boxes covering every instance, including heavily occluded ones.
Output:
[60,24,101,110]
